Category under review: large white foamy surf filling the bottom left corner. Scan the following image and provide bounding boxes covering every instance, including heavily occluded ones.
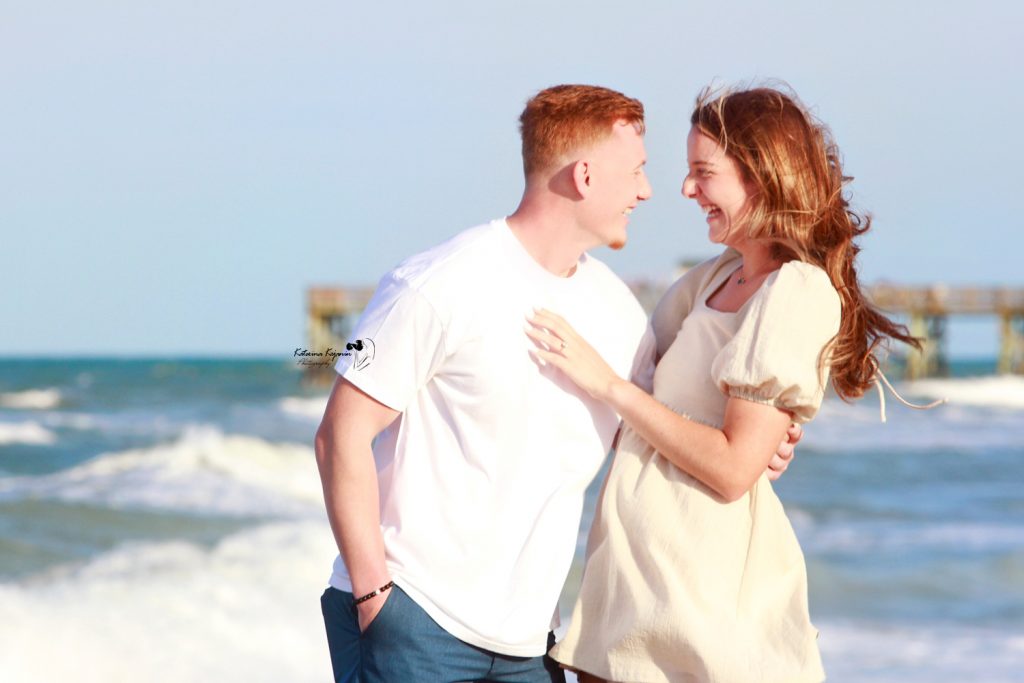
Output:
[0,520,337,683]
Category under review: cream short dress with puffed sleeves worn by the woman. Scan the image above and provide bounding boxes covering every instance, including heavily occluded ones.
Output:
[552,250,840,683]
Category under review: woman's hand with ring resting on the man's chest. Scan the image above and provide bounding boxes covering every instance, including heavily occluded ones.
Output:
[526,309,626,401]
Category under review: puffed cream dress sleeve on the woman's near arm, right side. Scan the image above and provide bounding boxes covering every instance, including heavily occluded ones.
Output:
[712,261,842,423]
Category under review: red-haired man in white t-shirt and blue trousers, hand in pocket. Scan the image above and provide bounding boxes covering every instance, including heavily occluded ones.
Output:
[316,86,794,683]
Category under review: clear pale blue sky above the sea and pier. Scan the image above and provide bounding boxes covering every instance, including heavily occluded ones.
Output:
[0,0,1024,355]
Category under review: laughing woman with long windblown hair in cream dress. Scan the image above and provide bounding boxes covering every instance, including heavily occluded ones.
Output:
[528,88,916,683]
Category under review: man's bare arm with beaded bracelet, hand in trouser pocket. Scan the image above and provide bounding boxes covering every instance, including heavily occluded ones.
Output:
[315,377,399,630]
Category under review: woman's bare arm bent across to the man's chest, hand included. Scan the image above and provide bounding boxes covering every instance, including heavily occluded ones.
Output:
[526,311,799,502]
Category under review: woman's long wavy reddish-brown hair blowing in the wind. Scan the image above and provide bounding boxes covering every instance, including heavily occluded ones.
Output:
[690,87,921,400]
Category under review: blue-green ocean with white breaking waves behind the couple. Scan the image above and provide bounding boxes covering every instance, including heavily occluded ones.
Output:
[0,358,1024,683]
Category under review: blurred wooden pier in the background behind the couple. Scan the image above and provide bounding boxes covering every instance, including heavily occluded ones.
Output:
[305,280,1024,384]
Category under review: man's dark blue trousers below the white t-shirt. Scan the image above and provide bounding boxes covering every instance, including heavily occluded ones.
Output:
[321,586,565,683]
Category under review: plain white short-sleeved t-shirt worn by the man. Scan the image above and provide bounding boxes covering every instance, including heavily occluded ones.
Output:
[331,220,653,656]
